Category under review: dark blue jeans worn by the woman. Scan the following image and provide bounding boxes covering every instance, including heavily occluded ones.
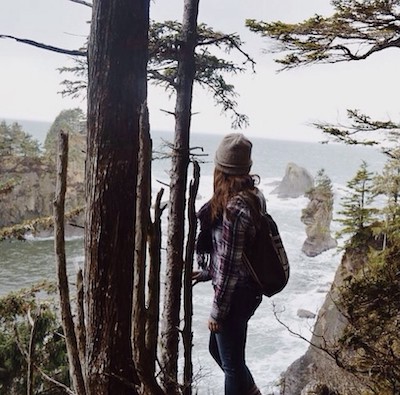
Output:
[209,288,262,395]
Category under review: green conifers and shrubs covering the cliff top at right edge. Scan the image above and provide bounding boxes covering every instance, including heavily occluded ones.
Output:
[331,154,400,395]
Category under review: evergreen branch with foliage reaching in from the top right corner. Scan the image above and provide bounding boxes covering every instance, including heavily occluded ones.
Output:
[246,0,400,70]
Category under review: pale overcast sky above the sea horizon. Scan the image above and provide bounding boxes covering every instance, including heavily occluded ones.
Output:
[0,0,400,141]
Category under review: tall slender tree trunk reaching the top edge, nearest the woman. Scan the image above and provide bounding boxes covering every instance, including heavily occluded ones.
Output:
[161,0,199,394]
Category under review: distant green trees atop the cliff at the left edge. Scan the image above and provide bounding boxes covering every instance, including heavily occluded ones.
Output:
[0,121,40,158]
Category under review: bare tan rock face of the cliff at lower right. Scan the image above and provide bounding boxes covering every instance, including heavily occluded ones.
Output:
[281,250,372,395]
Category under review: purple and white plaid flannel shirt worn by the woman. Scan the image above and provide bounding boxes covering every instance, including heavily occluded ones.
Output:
[207,196,255,321]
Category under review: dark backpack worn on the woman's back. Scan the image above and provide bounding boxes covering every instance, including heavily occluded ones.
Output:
[243,213,289,297]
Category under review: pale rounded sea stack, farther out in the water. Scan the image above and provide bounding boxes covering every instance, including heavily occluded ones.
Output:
[272,162,314,198]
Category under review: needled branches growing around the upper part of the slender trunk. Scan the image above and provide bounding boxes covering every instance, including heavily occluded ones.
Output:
[61,21,254,127]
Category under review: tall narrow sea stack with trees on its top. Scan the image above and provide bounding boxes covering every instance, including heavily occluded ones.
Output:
[301,170,337,257]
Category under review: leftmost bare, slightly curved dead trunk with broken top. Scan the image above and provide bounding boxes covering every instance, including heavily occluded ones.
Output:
[54,130,86,395]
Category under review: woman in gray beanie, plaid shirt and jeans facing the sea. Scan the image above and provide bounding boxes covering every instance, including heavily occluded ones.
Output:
[193,133,265,395]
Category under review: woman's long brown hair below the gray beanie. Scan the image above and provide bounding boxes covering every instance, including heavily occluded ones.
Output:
[211,169,260,222]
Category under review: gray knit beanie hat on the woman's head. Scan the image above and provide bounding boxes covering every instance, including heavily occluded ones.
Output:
[214,133,253,175]
